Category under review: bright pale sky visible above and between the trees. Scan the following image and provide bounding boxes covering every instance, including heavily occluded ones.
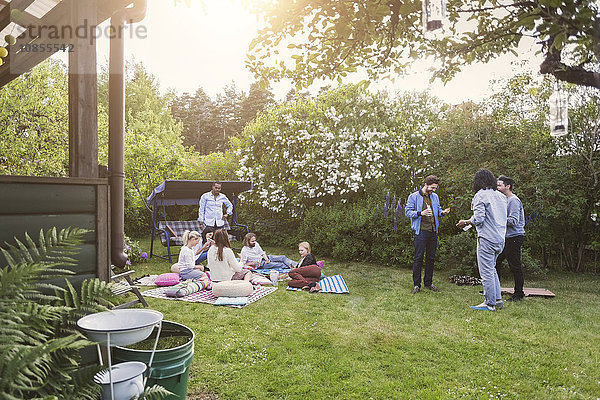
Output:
[90,0,539,104]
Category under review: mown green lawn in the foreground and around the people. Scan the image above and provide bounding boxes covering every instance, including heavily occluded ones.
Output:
[129,240,600,400]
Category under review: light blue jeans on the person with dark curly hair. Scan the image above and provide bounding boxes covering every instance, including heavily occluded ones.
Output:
[477,237,504,306]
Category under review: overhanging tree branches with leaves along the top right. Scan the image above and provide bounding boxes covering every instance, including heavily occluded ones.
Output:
[246,0,600,88]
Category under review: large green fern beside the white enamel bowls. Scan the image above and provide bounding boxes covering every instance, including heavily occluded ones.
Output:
[0,228,115,399]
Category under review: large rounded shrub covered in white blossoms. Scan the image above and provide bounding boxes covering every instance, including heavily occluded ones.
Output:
[232,86,438,217]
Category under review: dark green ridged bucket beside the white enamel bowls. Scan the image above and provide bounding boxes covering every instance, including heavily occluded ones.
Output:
[112,321,195,400]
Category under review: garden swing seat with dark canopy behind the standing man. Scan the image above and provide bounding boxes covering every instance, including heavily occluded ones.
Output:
[146,180,252,262]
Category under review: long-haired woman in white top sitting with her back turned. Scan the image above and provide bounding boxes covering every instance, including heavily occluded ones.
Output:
[207,229,252,282]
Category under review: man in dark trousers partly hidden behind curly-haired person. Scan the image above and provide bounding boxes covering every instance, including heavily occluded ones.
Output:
[496,175,525,301]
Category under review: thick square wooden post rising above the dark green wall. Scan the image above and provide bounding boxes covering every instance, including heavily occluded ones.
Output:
[69,0,98,178]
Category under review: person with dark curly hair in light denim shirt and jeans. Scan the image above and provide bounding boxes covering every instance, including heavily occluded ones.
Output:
[456,169,507,311]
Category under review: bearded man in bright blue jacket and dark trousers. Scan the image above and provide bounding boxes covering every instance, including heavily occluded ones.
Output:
[404,175,450,294]
